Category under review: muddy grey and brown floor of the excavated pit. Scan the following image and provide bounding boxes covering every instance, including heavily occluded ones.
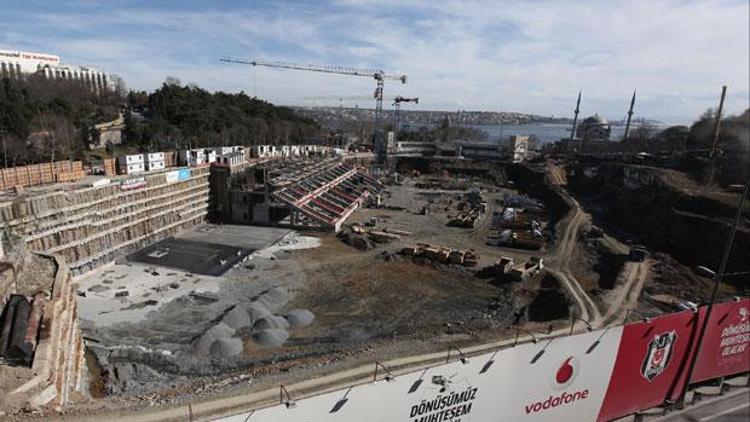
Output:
[70,182,569,397]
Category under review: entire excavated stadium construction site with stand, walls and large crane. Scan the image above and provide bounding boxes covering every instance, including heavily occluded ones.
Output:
[0,54,750,420]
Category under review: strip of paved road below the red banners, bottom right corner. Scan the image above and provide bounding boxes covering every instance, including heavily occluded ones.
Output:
[652,389,750,422]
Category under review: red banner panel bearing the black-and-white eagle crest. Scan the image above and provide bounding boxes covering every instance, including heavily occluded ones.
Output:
[598,311,701,421]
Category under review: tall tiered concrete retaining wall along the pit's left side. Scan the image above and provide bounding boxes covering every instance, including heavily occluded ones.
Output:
[0,168,209,273]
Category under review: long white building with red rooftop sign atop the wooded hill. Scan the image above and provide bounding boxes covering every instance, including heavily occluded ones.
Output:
[0,50,115,91]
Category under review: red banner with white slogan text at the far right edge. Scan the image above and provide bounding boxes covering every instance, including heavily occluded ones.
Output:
[691,299,750,382]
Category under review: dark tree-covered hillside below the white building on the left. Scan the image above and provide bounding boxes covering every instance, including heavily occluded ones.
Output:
[0,75,321,167]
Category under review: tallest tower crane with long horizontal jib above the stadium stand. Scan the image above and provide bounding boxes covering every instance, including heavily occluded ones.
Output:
[220,57,406,163]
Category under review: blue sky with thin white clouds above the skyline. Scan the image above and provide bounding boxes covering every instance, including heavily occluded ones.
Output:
[0,0,750,121]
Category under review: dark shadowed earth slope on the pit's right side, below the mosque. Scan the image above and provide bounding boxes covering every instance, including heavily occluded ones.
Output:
[569,163,750,282]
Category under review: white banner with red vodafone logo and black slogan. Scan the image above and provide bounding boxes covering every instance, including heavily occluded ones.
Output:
[221,327,622,422]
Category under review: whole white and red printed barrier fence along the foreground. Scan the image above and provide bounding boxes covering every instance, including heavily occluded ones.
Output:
[221,298,750,422]
